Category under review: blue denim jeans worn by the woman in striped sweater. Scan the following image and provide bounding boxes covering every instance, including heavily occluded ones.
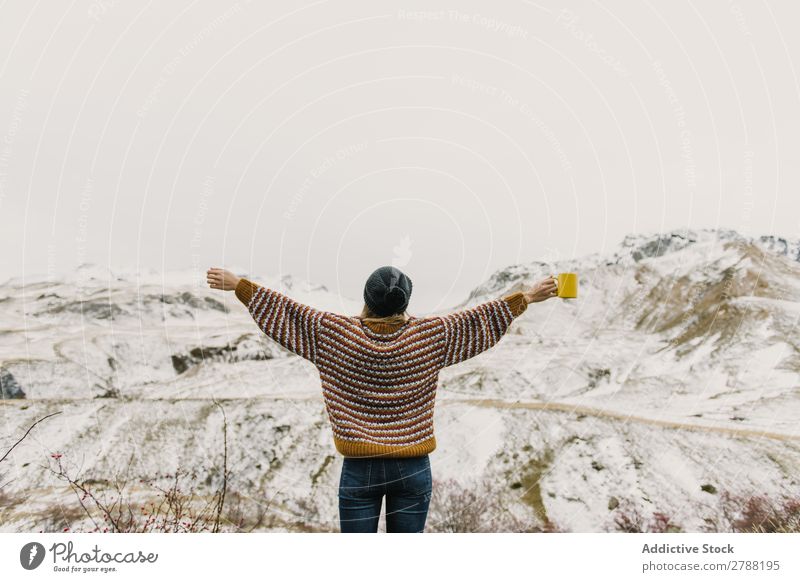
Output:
[339,455,432,533]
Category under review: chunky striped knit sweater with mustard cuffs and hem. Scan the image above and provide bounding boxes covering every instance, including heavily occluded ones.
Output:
[236,278,528,457]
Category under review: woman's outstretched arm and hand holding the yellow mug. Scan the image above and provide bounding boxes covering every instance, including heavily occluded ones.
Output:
[439,277,556,366]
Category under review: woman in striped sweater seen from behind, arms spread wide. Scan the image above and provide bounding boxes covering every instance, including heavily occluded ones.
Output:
[207,266,557,533]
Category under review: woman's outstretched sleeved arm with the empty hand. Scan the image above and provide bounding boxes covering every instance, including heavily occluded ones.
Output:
[207,268,327,363]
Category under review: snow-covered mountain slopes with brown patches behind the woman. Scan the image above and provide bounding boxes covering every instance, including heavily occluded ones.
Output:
[0,229,800,531]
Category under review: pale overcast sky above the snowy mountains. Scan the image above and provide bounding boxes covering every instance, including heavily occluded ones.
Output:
[0,0,800,313]
